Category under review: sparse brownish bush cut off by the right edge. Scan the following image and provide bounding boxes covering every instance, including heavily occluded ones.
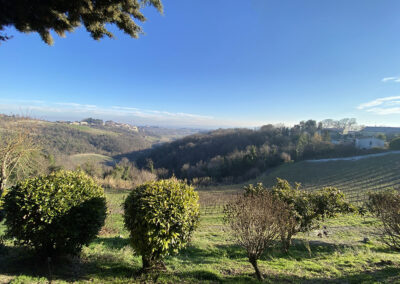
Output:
[367,190,400,250]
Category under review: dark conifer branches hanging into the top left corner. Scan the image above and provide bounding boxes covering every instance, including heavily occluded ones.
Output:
[0,0,163,45]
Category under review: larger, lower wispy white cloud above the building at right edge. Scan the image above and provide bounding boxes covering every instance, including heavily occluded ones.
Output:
[357,96,400,115]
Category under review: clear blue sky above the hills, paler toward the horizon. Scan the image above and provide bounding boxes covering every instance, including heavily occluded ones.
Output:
[0,0,400,127]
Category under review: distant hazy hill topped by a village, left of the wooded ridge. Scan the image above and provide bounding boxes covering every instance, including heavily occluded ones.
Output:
[0,115,197,156]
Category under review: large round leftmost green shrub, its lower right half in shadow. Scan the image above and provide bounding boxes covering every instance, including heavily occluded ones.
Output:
[4,171,106,256]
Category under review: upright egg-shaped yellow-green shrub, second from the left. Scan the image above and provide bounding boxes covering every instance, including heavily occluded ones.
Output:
[124,179,199,271]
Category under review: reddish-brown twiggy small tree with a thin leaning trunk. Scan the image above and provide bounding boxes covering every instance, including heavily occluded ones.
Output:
[224,191,290,280]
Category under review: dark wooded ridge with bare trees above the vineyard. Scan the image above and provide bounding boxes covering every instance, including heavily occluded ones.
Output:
[136,120,382,185]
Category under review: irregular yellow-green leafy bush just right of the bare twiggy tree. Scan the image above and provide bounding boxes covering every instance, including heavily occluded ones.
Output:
[244,178,355,252]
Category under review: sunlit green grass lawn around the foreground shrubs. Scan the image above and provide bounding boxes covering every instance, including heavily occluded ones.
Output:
[0,187,400,283]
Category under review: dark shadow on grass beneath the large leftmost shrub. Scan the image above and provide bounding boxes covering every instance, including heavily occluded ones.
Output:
[0,238,141,282]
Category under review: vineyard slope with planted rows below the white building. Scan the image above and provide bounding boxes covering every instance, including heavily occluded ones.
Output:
[255,152,400,201]
